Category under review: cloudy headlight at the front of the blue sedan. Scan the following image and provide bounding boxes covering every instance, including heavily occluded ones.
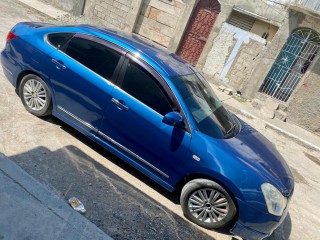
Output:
[261,183,287,216]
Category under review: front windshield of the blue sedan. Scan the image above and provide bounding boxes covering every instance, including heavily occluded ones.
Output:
[171,73,238,138]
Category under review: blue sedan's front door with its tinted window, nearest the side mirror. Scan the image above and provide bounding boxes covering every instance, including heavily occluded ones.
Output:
[99,56,191,189]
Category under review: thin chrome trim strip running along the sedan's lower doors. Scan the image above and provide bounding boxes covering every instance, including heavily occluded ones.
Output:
[57,106,169,178]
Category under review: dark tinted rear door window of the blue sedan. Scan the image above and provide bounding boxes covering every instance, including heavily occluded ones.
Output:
[66,37,121,79]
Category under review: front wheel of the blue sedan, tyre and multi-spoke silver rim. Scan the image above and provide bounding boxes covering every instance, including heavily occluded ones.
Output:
[180,179,237,229]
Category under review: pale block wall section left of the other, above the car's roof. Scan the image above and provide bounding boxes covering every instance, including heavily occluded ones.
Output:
[93,0,132,29]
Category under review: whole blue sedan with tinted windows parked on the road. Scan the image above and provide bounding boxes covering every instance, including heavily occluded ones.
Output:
[1,22,294,239]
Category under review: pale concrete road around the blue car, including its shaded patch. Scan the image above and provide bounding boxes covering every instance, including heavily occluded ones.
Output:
[0,0,320,240]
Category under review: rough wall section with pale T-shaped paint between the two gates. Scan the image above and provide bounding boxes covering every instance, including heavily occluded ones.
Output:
[203,23,266,87]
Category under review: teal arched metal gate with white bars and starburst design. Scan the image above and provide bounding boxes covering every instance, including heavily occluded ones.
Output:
[259,28,320,102]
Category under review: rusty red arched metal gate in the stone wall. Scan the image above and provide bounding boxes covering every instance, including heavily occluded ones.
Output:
[177,0,220,66]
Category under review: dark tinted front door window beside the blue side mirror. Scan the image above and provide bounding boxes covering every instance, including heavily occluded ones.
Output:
[121,63,172,115]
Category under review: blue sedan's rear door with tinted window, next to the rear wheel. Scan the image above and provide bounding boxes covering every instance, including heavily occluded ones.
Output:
[48,34,125,132]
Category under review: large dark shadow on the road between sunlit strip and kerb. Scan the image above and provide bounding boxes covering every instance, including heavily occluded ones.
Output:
[10,143,220,239]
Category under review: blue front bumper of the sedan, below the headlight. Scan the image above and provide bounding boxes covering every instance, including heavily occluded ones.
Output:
[230,199,288,240]
